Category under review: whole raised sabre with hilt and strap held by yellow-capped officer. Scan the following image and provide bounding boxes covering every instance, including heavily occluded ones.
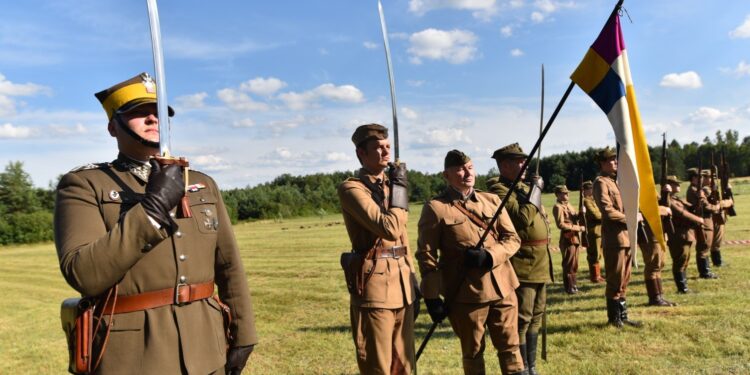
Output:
[146,0,193,217]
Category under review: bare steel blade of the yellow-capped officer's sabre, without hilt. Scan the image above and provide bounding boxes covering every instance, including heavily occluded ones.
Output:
[146,0,172,157]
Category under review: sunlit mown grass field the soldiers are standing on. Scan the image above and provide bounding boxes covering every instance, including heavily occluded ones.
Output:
[0,179,750,374]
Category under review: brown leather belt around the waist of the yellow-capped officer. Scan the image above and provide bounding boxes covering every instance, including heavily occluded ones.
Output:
[104,280,214,315]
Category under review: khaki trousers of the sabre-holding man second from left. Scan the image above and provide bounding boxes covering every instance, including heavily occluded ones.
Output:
[349,305,416,375]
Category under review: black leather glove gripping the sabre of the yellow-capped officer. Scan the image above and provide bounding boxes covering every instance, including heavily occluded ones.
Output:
[141,159,185,229]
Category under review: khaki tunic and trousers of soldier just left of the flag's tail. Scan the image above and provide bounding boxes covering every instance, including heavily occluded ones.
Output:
[594,174,633,300]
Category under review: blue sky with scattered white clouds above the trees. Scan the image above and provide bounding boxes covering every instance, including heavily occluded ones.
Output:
[0,0,750,188]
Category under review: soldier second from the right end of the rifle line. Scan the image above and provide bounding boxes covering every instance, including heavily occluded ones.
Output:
[687,168,720,279]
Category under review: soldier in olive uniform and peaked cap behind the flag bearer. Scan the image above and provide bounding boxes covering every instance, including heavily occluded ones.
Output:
[487,143,552,375]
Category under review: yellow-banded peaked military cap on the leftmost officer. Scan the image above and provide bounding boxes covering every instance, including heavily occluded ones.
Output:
[94,73,174,120]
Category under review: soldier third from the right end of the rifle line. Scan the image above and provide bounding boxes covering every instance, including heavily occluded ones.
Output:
[662,176,703,294]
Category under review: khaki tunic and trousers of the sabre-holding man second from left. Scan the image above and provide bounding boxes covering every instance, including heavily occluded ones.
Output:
[338,169,418,374]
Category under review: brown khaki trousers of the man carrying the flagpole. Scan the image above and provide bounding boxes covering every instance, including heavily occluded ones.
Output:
[448,293,523,375]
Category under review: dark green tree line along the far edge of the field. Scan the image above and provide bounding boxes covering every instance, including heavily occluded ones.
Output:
[0,130,750,245]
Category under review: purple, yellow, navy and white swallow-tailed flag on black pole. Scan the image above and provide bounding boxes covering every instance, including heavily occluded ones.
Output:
[570,12,666,253]
